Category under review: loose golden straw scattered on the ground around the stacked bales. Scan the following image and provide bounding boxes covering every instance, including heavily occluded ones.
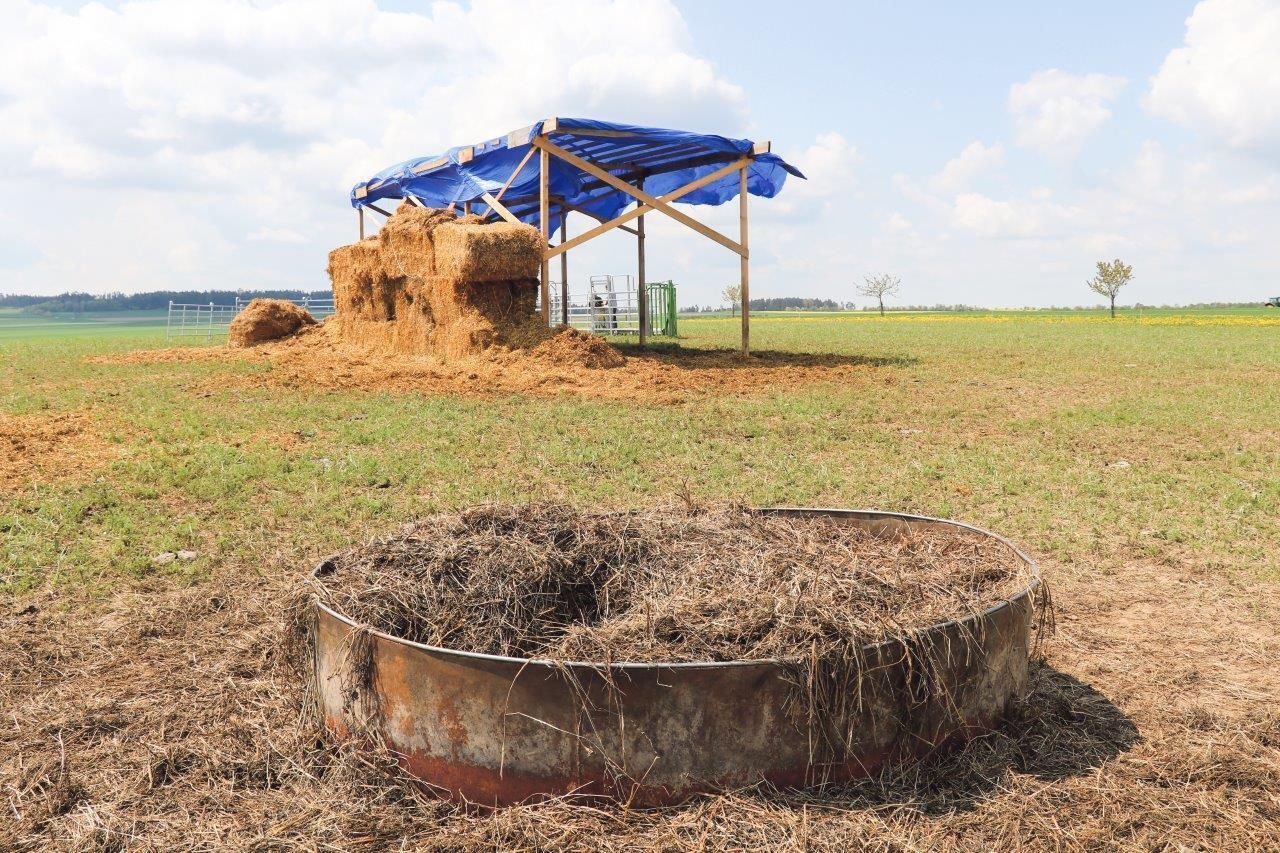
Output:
[92,320,895,403]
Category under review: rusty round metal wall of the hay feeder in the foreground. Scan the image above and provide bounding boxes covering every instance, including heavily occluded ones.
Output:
[309,508,1039,806]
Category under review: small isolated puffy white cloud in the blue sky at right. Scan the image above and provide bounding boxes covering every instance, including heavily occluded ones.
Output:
[1009,68,1125,158]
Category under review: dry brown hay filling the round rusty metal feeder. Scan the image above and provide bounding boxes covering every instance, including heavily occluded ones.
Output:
[319,505,1032,662]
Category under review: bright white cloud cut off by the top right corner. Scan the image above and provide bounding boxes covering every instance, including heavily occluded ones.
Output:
[1144,0,1280,156]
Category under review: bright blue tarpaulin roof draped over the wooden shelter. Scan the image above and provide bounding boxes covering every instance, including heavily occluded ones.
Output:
[351,118,804,233]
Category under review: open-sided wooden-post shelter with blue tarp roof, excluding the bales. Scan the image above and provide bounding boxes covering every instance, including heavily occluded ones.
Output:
[351,118,804,352]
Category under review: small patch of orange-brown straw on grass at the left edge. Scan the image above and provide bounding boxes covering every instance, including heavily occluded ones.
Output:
[0,412,116,492]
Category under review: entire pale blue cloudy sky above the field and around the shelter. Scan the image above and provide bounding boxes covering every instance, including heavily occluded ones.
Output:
[0,0,1280,306]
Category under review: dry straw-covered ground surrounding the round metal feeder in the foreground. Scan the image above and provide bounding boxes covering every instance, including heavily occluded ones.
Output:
[0,540,1280,850]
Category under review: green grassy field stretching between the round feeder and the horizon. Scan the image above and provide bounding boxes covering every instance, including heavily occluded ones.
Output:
[0,309,1280,589]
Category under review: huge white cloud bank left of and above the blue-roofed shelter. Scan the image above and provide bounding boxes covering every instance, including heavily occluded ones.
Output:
[0,0,748,292]
